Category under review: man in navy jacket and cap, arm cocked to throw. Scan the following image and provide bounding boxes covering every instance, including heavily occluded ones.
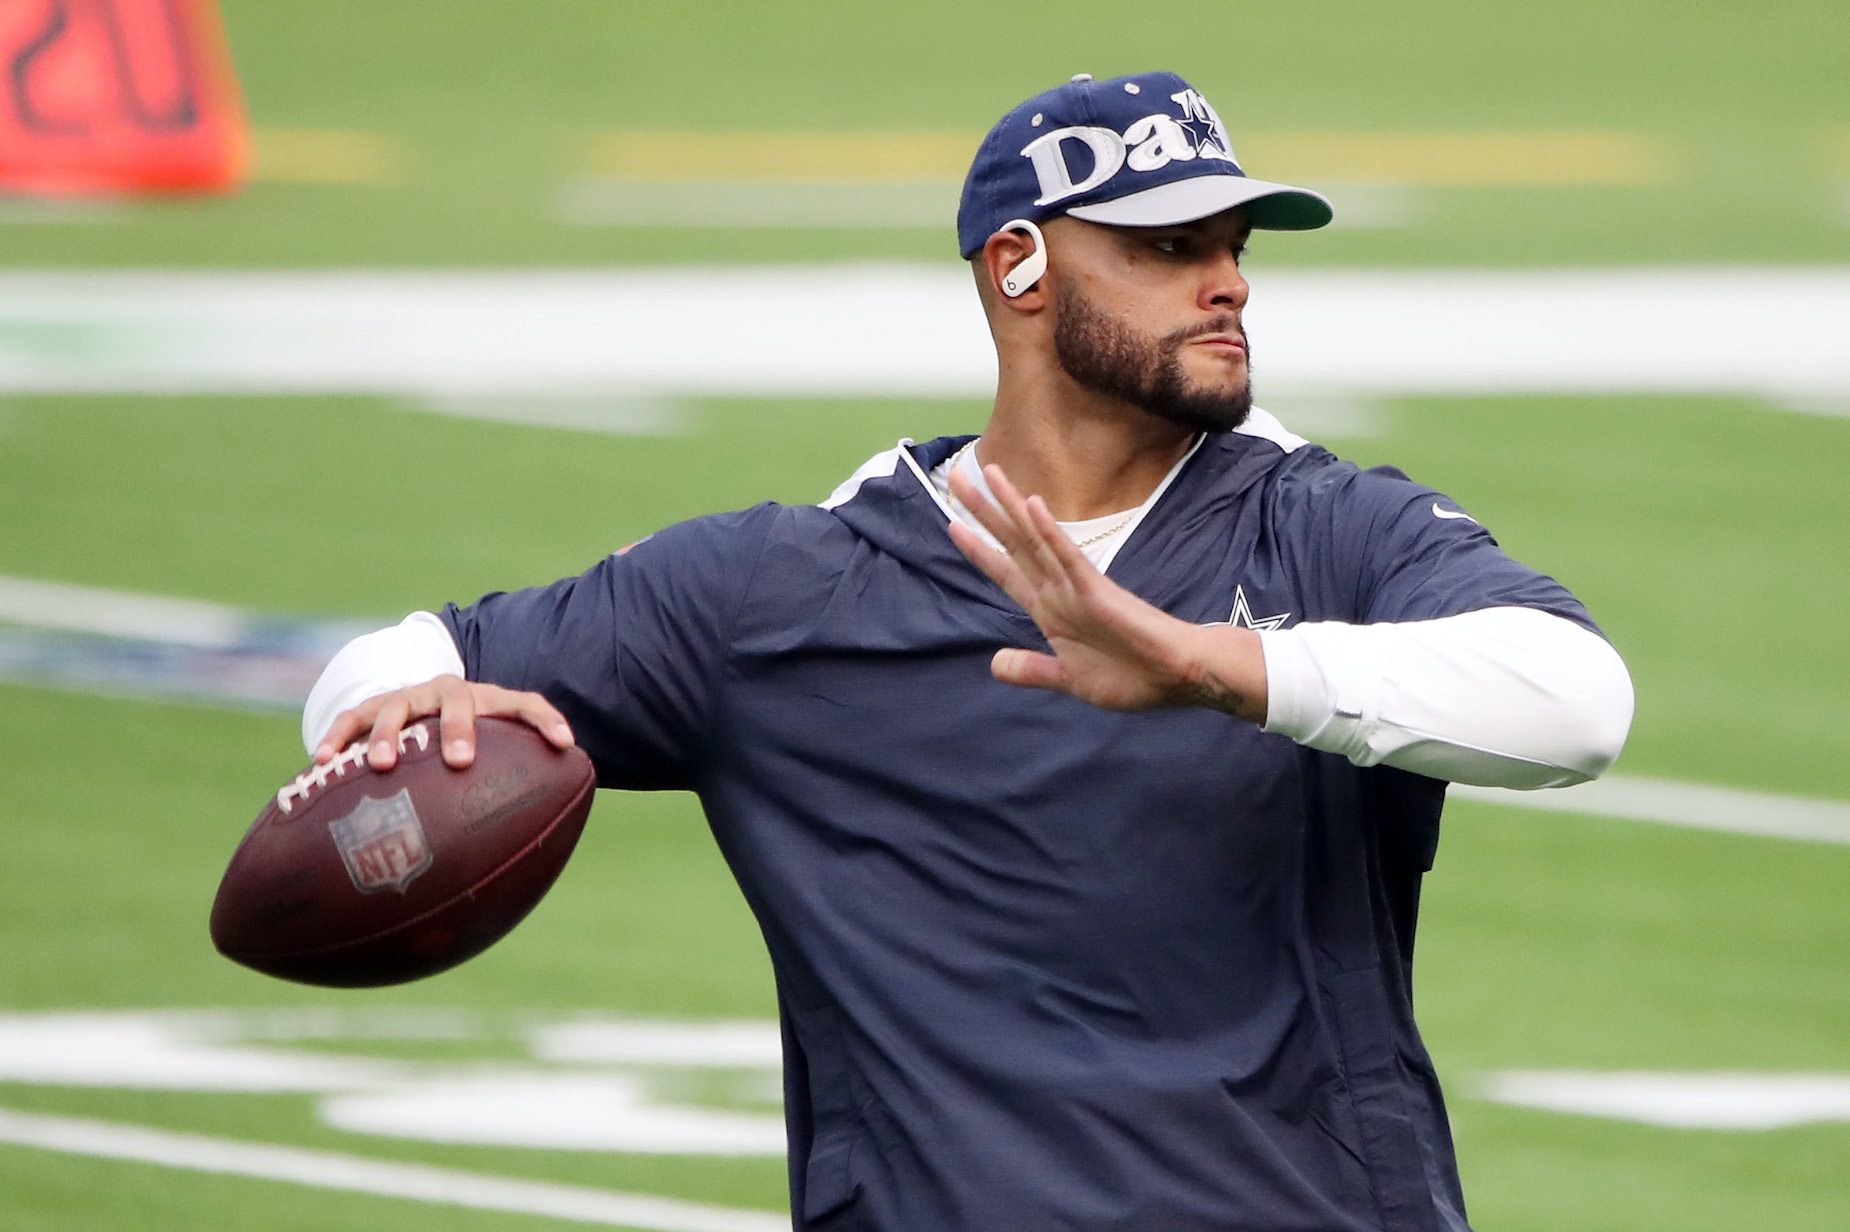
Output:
[303,72,1632,1232]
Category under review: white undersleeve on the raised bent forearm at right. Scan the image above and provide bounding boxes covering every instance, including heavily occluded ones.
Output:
[1260,607,1632,788]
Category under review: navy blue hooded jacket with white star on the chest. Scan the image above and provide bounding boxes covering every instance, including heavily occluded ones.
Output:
[444,433,1591,1232]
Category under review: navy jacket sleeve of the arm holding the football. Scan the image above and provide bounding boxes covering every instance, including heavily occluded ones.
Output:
[442,505,775,790]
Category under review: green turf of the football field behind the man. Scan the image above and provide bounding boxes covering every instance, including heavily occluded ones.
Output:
[0,0,1850,1232]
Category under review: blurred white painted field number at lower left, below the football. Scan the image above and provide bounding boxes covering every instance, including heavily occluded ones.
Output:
[0,1012,784,1156]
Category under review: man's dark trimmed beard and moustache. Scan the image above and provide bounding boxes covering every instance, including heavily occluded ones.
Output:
[1053,283,1252,433]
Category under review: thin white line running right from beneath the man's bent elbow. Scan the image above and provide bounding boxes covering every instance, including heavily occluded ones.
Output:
[1450,775,1850,844]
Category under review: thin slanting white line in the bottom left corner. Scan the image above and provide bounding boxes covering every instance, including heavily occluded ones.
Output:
[0,1110,790,1232]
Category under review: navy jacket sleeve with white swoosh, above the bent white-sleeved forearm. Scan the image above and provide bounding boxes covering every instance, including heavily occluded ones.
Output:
[1330,466,1598,633]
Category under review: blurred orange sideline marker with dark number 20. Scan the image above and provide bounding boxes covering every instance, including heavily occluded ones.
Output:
[0,0,250,196]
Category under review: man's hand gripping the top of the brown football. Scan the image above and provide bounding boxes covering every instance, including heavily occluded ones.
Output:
[315,675,575,770]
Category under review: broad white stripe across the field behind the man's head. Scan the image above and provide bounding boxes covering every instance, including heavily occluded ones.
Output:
[0,264,1850,395]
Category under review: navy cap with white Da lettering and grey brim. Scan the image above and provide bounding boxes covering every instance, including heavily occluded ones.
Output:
[956,72,1332,257]
